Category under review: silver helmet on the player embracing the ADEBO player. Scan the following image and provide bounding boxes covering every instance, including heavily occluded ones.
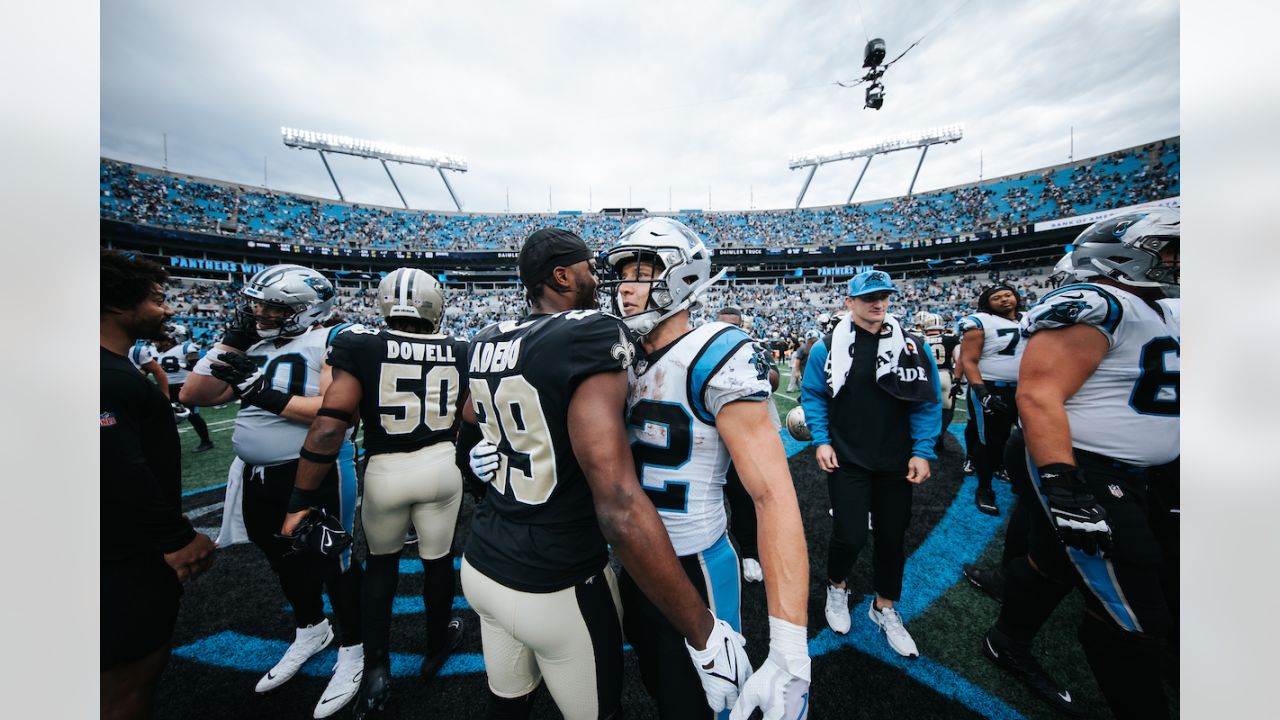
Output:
[600,218,724,336]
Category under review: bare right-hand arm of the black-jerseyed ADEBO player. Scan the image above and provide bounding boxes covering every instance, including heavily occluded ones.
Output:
[568,372,714,650]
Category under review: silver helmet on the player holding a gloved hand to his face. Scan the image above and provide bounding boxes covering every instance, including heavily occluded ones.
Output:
[236,265,334,338]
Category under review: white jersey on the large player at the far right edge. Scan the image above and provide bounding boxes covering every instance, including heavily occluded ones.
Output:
[1023,283,1181,466]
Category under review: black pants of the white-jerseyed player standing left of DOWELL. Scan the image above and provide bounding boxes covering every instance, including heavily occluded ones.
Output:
[242,460,364,646]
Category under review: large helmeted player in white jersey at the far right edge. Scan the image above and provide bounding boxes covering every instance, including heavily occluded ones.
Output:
[983,209,1181,717]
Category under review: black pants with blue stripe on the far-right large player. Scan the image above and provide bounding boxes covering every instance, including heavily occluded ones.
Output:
[997,437,1172,717]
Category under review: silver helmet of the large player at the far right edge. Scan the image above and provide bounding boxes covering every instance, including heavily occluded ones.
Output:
[1070,208,1181,295]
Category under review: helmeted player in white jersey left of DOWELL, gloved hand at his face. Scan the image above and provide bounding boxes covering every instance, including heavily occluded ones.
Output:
[182,265,364,717]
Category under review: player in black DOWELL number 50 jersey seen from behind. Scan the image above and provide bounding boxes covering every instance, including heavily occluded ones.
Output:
[280,268,467,717]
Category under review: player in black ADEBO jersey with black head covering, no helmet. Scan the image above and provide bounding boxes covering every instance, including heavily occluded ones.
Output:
[460,228,747,720]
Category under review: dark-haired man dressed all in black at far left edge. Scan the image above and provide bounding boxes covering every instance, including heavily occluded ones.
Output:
[99,251,214,719]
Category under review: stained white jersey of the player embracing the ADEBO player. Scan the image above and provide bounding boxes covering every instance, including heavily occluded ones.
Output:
[627,322,771,556]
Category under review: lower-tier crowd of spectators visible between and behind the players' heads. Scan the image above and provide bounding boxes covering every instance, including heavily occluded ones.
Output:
[169,260,1052,346]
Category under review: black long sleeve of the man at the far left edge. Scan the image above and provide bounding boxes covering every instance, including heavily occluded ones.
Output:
[99,373,196,552]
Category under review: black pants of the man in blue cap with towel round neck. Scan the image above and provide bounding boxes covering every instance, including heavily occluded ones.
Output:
[827,461,911,602]
